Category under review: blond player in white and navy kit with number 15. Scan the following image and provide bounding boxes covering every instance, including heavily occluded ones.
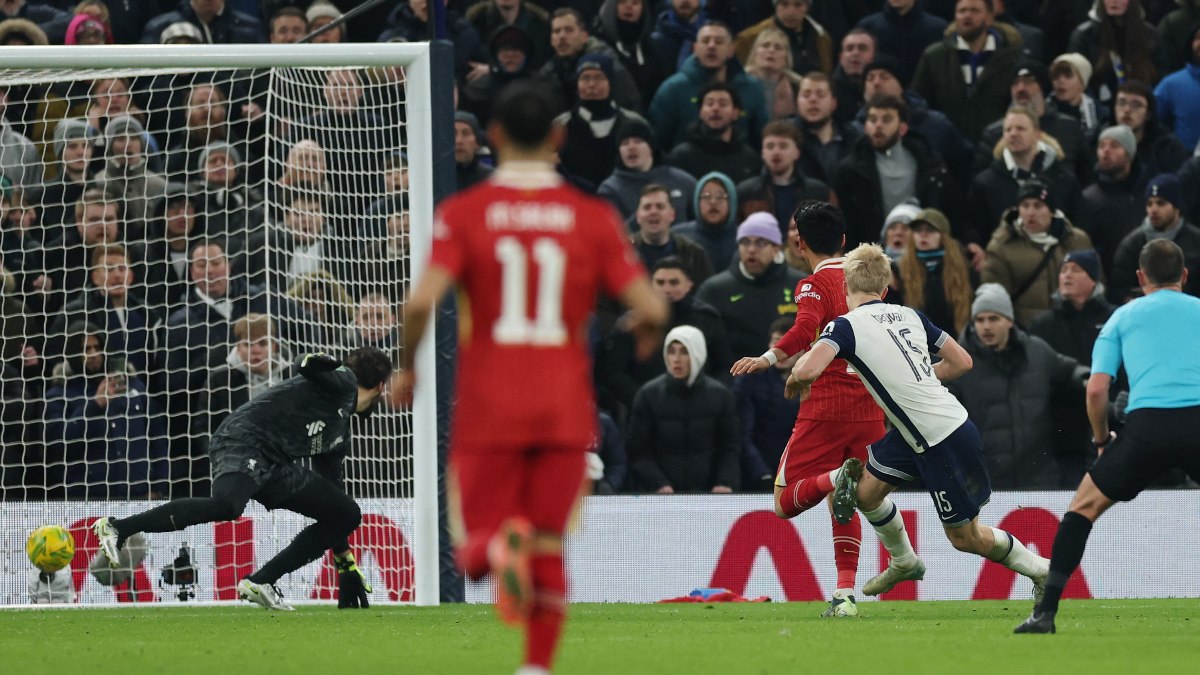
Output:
[787,244,1050,602]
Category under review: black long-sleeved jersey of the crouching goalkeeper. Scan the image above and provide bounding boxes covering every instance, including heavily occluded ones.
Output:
[210,357,358,458]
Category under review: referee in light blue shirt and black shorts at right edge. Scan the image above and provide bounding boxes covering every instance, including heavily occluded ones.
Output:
[1014,239,1200,633]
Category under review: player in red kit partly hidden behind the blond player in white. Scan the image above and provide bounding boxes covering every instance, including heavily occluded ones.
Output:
[730,201,887,616]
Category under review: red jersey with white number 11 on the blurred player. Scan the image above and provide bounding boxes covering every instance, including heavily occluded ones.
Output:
[431,163,646,450]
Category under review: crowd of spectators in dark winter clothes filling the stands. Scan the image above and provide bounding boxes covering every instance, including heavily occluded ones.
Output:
[0,0,1200,497]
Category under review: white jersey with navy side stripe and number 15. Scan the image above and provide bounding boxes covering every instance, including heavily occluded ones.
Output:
[817,300,967,453]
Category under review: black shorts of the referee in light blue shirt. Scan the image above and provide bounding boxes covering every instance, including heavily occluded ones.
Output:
[1088,407,1200,502]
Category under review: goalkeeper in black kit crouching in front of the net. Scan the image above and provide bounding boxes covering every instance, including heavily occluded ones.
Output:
[92,347,391,610]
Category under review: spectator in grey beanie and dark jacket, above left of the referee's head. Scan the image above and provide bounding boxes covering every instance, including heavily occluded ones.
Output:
[1075,125,1153,279]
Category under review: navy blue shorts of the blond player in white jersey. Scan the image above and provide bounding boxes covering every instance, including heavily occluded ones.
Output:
[866,419,991,527]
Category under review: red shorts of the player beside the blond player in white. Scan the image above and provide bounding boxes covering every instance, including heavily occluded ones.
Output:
[775,419,887,488]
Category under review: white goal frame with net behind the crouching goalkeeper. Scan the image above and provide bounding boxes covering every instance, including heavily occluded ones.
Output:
[0,44,437,605]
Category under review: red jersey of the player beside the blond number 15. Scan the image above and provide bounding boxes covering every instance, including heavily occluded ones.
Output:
[775,258,883,422]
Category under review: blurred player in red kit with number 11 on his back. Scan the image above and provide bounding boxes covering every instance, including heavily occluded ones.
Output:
[401,80,667,674]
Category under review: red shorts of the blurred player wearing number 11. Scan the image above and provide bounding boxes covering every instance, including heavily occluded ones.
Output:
[448,443,587,543]
